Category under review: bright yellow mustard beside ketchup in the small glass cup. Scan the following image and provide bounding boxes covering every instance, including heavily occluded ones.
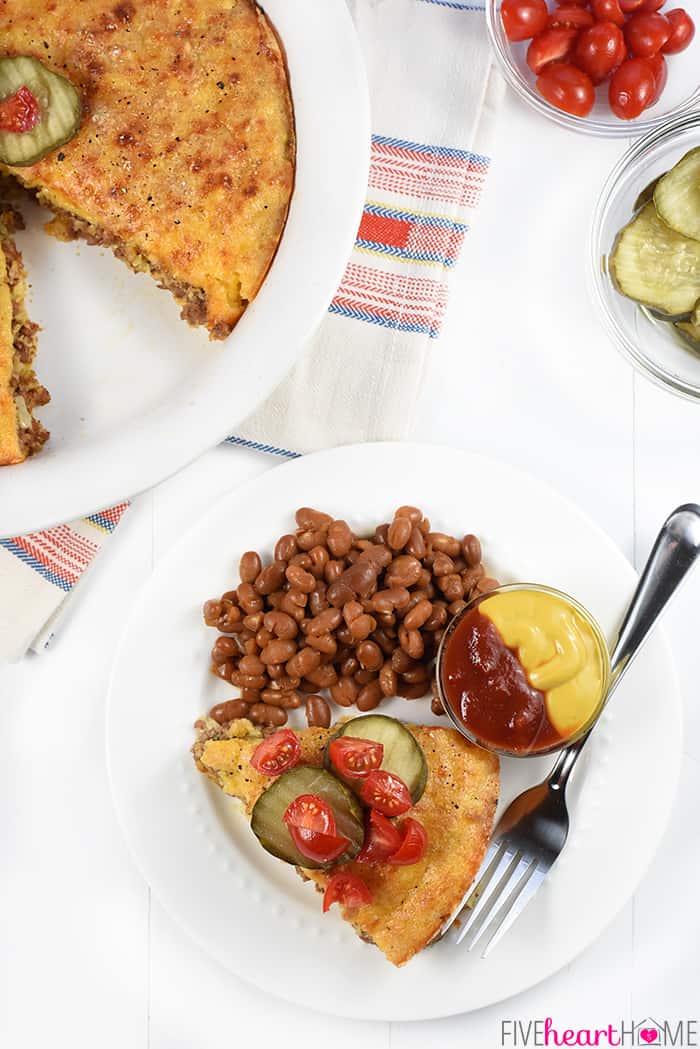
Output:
[479,590,606,738]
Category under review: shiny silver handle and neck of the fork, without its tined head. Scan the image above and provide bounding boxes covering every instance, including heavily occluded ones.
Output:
[548,502,700,791]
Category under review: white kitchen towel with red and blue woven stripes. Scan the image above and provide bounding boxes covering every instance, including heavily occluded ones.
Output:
[0,0,503,663]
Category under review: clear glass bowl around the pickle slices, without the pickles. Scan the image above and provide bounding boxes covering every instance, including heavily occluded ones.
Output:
[589,112,700,400]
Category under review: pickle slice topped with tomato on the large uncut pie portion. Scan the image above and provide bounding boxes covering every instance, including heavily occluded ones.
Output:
[0,56,82,168]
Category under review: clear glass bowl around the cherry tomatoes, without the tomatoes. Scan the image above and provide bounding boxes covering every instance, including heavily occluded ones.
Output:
[486,0,700,138]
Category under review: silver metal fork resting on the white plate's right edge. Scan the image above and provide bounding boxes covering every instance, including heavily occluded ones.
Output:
[443,504,700,958]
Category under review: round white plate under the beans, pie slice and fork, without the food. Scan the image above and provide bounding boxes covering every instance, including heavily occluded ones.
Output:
[107,444,681,1020]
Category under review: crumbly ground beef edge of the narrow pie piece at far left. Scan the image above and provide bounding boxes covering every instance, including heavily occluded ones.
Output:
[2,238,50,455]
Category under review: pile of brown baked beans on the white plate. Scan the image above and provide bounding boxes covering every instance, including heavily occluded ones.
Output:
[204,507,499,727]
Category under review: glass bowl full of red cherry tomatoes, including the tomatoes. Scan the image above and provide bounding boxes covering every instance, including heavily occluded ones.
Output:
[493,0,700,137]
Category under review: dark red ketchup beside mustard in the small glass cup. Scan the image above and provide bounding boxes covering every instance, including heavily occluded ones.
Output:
[442,605,563,753]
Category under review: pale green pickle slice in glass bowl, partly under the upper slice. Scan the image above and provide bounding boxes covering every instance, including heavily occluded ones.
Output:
[610,201,700,320]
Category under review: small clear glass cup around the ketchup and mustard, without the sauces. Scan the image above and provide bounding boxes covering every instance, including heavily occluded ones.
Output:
[436,583,610,757]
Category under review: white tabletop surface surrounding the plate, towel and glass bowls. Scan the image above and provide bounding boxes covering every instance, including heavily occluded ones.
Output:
[0,86,700,1049]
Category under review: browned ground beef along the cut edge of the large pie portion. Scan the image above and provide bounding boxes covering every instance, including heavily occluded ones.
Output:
[43,202,219,339]
